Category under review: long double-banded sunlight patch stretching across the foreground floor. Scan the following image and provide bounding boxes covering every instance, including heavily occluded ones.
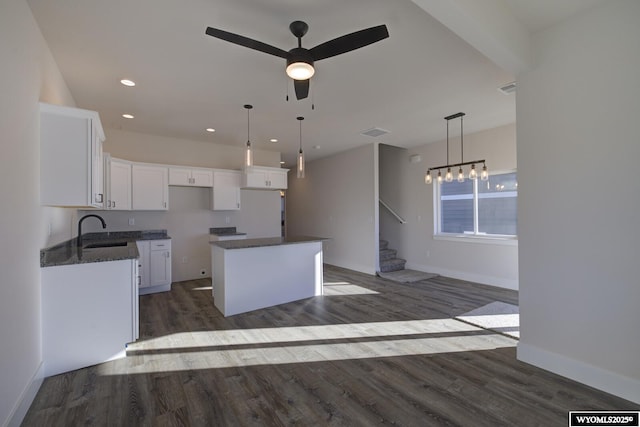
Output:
[98,319,516,375]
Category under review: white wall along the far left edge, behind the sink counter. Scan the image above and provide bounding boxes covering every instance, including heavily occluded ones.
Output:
[0,0,74,425]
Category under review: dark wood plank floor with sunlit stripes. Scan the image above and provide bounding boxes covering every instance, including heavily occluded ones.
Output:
[23,266,638,427]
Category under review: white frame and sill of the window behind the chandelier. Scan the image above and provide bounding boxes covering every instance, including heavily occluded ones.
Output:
[433,169,518,246]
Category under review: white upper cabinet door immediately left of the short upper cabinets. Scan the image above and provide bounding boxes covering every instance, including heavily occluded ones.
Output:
[131,164,169,211]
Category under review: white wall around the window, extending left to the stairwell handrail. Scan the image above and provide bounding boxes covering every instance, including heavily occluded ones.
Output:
[380,123,518,289]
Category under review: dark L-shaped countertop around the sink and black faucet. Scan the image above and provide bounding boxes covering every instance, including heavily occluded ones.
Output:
[40,230,170,267]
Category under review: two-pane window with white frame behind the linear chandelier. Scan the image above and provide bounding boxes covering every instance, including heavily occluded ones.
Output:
[435,172,518,237]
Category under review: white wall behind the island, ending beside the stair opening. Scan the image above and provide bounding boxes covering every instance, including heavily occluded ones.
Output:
[287,144,378,274]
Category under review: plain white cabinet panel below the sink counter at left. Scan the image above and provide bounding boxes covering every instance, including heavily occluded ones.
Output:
[41,259,138,376]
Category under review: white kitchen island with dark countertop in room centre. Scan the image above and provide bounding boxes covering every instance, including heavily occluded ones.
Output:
[211,236,326,317]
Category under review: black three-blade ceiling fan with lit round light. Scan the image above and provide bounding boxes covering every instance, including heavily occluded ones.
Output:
[206,21,389,99]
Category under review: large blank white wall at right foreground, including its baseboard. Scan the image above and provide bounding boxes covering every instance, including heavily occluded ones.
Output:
[517,0,640,402]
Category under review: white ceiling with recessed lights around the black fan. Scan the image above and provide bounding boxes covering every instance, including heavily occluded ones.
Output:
[28,0,602,166]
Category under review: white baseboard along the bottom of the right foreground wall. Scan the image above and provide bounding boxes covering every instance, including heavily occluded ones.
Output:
[517,341,640,404]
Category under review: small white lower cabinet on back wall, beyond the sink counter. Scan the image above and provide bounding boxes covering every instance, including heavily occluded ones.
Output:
[136,239,171,295]
